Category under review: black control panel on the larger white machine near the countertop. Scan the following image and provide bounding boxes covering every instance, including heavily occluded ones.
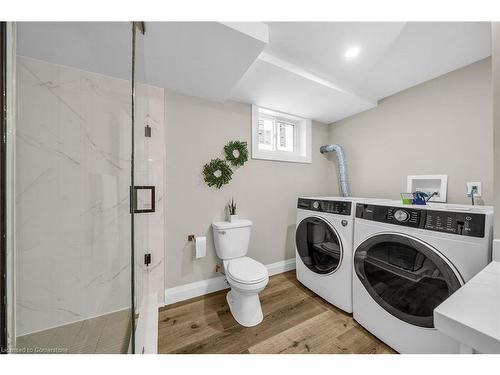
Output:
[356,203,486,237]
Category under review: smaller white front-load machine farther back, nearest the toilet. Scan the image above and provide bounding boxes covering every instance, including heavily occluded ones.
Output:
[295,197,386,313]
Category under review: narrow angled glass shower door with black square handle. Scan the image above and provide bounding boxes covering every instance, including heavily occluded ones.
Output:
[133,22,166,353]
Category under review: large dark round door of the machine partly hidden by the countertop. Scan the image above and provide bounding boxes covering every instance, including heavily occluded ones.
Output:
[354,233,462,328]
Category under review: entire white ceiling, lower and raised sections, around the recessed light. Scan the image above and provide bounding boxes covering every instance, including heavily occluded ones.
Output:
[18,22,491,123]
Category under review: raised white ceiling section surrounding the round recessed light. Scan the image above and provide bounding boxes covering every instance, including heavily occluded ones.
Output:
[265,22,491,100]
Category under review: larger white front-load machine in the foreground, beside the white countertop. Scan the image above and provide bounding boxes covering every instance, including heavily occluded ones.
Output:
[353,201,493,353]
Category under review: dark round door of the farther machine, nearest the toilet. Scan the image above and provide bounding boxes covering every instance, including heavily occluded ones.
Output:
[295,216,342,274]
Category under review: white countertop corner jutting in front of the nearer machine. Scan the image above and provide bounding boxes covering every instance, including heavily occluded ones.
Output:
[434,262,500,353]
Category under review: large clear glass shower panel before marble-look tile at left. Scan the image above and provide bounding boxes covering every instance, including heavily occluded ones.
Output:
[11,22,148,353]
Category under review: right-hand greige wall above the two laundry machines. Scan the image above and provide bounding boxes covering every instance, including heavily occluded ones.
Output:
[330,59,493,204]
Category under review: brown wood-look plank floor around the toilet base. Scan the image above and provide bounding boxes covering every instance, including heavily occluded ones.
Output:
[158,271,395,354]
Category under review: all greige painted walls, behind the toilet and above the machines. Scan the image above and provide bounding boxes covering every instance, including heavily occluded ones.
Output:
[165,59,493,288]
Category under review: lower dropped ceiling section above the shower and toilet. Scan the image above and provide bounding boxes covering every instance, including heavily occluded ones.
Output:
[17,22,268,101]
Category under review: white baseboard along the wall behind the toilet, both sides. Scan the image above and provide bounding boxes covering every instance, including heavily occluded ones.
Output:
[165,258,295,305]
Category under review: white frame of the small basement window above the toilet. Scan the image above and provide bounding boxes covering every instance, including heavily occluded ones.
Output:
[252,105,312,163]
